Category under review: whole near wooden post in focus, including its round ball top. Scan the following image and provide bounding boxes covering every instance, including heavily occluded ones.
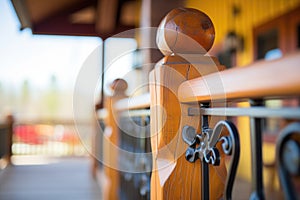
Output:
[150,8,226,200]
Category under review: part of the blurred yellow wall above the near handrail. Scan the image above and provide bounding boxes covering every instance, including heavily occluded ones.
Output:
[186,0,300,66]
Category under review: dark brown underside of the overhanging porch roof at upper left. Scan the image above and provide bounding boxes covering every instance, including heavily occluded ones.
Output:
[11,0,139,39]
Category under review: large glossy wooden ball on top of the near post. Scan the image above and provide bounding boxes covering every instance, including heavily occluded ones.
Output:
[156,8,215,55]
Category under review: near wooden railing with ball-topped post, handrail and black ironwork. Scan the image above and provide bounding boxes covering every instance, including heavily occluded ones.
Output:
[150,9,300,199]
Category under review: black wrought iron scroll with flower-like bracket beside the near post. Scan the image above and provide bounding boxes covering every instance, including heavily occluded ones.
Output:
[182,119,240,199]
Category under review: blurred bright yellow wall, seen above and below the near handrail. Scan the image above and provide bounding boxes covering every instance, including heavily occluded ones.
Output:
[186,0,300,180]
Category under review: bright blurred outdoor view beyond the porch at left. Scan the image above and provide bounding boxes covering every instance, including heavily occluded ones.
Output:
[0,0,137,156]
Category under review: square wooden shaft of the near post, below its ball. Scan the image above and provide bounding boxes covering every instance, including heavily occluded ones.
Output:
[150,55,226,200]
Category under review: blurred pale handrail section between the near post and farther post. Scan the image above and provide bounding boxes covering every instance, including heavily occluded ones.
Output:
[115,93,150,111]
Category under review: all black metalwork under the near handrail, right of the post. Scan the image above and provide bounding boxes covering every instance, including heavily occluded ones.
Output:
[182,99,300,200]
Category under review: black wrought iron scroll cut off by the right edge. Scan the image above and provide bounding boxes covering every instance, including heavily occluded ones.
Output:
[276,122,300,200]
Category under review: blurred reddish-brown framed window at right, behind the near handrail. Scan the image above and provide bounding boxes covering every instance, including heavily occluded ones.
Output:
[253,7,300,140]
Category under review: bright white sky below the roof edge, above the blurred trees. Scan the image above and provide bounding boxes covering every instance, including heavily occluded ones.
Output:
[0,0,102,88]
